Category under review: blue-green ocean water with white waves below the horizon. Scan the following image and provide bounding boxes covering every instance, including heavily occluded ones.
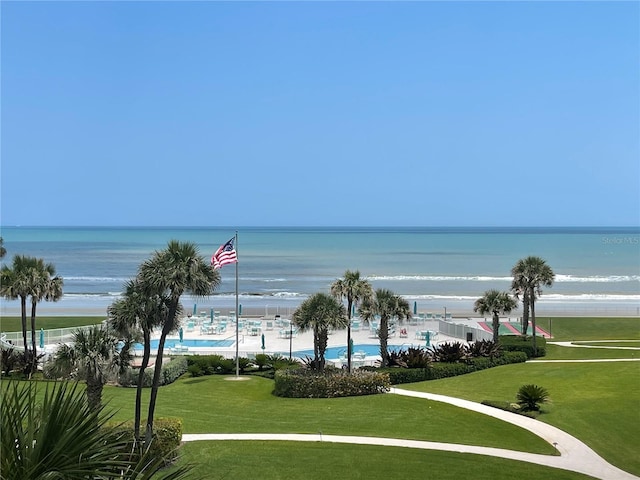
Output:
[0,227,640,315]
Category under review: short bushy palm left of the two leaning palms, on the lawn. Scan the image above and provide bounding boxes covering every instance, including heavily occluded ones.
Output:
[53,325,132,410]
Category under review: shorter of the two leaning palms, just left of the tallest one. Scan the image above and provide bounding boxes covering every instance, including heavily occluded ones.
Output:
[108,278,168,441]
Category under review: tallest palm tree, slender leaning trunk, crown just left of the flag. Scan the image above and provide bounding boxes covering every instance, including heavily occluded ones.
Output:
[138,240,220,444]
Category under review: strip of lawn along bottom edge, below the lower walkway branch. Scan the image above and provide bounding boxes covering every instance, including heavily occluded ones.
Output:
[174,441,593,480]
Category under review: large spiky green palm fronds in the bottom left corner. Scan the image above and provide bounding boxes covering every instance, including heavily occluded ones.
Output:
[0,381,189,480]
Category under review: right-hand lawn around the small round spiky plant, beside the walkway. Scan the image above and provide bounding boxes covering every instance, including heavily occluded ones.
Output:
[403,362,640,475]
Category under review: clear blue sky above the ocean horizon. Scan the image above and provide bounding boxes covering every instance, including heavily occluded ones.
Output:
[0,2,640,227]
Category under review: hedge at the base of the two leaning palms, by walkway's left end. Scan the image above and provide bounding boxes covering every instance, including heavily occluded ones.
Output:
[107,418,182,465]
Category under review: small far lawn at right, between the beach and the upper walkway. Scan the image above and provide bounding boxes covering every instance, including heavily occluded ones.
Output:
[536,317,640,342]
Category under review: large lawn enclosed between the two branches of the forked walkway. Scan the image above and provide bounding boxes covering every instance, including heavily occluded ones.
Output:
[104,376,554,455]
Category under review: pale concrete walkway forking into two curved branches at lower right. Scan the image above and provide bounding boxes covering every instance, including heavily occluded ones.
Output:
[182,388,640,480]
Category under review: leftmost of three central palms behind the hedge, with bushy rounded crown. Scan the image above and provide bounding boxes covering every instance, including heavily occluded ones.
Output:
[293,293,349,371]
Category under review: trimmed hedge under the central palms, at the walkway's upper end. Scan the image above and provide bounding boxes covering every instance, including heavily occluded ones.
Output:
[274,369,391,398]
